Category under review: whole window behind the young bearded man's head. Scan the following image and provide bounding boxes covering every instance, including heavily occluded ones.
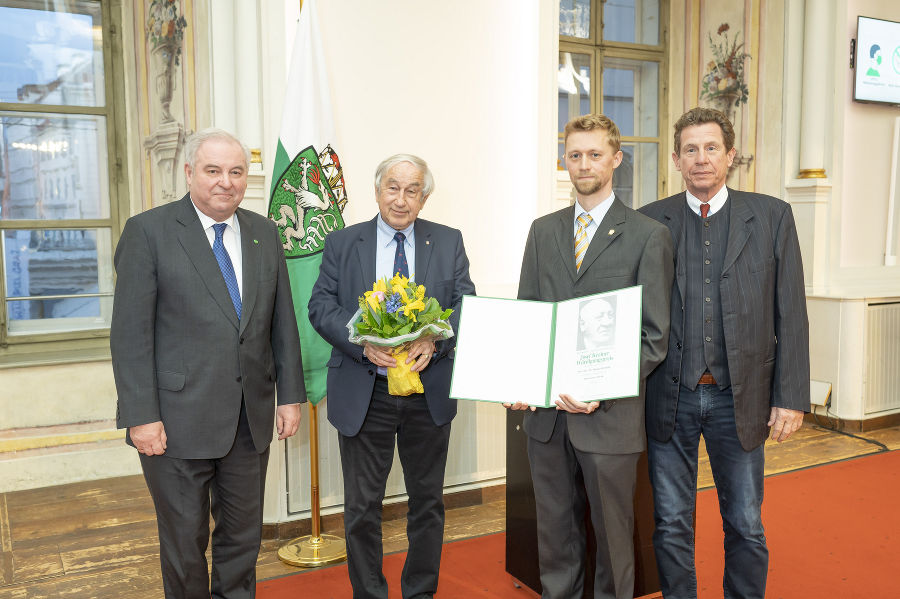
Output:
[557,0,667,208]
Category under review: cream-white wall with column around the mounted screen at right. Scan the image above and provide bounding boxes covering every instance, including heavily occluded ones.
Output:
[783,0,900,420]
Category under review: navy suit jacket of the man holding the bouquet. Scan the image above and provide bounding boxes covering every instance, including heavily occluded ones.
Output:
[309,217,475,437]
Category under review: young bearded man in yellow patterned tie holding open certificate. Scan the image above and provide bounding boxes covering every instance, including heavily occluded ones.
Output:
[511,114,673,599]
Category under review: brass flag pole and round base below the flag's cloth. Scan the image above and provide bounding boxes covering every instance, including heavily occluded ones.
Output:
[278,402,347,568]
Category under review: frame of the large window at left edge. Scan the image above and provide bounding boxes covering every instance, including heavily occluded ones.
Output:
[0,0,128,368]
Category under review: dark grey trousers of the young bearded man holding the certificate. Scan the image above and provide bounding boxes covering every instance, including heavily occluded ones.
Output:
[528,414,640,599]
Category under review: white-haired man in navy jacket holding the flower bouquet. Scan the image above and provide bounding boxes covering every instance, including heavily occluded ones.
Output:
[309,154,475,598]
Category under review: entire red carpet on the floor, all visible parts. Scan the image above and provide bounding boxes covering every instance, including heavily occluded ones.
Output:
[256,451,900,599]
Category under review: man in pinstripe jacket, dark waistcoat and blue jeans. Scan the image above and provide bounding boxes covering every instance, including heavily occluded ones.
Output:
[641,108,809,599]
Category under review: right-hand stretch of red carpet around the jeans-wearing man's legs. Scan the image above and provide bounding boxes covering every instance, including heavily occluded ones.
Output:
[697,451,900,599]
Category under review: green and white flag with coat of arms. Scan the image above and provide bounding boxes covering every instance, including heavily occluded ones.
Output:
[268,0,347,404]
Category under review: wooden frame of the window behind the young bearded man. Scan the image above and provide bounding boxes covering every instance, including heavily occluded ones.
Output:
[557,0,669,208]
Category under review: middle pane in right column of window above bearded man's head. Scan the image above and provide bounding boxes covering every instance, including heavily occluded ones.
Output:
[603,56,659,137]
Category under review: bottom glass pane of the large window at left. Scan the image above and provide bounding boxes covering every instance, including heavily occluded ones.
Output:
[3,229,113,335]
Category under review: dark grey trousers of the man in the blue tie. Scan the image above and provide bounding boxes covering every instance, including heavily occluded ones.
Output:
[141,406,269,599]
